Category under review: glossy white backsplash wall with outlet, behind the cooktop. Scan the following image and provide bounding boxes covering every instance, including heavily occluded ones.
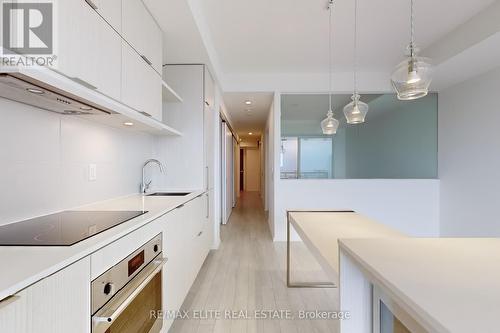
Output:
[0,98,156,224]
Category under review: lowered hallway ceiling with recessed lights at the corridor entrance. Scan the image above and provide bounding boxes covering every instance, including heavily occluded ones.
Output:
[223,92,274,137]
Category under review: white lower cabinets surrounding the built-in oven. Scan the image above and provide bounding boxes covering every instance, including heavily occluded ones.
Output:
[0,192,213,333]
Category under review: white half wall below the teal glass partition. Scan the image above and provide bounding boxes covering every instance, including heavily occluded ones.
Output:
[275,179,439,241]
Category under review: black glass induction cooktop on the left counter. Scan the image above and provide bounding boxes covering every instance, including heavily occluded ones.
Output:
[0,210,147,246]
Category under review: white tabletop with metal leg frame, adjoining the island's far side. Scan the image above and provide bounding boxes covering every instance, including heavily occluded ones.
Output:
[290,212,405,281]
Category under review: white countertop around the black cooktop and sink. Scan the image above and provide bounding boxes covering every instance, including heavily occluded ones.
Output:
[0,190,204,300]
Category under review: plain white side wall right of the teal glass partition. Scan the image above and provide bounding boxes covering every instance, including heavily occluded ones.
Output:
[439,68,500,237]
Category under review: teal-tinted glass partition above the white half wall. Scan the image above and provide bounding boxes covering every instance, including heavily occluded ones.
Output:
[280,94,438,179]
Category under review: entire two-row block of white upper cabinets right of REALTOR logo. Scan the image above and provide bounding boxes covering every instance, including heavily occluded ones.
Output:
[58,0,162,121]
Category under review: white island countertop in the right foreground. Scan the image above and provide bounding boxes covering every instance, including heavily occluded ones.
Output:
[340,238,500,333]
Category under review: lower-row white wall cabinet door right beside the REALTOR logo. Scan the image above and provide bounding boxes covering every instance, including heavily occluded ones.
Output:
[56,0,121,100]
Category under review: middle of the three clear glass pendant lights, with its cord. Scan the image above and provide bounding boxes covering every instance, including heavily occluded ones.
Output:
[344,0,368,124]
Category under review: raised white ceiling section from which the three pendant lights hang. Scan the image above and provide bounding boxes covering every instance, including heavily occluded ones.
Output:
[199,0,494,73]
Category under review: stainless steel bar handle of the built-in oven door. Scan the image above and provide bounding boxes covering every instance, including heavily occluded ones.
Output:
[92,254,168,332]
